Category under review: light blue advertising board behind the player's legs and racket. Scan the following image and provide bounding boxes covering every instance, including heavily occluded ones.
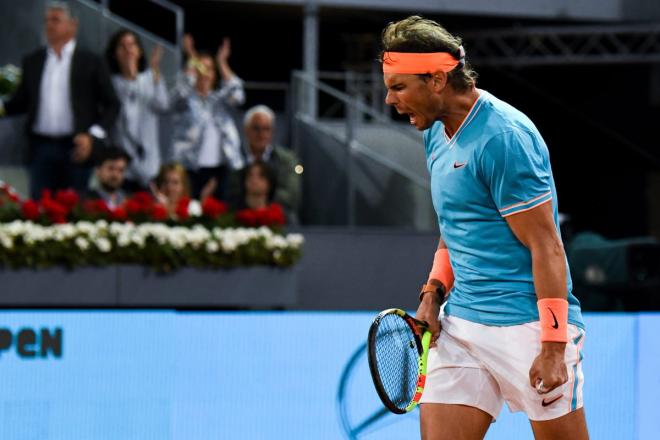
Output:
[0,311,660,440]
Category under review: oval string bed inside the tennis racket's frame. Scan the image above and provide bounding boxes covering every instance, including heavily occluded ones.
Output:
[376,314,419,409]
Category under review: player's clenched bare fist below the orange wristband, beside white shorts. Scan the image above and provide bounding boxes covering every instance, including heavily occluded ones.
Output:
[529,342,568,394]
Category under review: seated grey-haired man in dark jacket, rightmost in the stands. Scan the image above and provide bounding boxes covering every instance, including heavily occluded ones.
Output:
[230,105,302,223]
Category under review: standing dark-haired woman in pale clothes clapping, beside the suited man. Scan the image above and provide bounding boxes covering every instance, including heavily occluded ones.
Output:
[106,29,168,192]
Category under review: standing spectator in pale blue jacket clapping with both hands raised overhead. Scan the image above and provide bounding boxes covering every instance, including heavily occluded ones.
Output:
[172,36,245,199]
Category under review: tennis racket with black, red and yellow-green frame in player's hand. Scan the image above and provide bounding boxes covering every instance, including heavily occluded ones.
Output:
[367,309,431,414]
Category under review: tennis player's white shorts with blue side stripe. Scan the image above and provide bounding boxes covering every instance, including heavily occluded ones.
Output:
[421,315,584,420]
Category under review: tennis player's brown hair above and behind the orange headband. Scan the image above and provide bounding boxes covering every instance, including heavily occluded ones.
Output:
[380,15,477,92]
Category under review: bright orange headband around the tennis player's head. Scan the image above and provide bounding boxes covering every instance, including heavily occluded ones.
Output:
[383,46,465,75]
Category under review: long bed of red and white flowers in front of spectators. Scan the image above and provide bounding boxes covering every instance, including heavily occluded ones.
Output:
[0,186,304,271]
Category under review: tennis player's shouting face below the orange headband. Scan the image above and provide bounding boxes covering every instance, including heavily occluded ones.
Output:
[384,73,437,130]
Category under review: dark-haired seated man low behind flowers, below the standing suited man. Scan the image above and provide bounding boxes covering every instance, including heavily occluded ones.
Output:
[85,147,131,209]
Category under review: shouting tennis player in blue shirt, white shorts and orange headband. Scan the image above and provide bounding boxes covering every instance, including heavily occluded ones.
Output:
[381,16,588,440]
